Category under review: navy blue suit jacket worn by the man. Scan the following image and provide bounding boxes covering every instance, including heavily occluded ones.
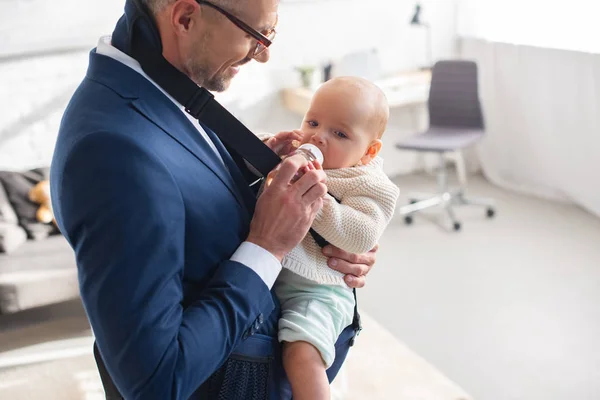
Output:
[51,52,284,399]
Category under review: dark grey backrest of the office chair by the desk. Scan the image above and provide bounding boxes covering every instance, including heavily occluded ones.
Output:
[428,60,484,129]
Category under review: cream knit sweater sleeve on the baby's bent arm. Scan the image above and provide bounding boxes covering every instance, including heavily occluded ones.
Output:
[312,165,399,254]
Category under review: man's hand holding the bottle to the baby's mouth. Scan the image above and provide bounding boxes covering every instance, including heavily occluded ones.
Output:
[247,155,327,261]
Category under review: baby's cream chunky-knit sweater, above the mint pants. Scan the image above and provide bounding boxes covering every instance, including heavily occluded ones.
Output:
[282,157,399,286]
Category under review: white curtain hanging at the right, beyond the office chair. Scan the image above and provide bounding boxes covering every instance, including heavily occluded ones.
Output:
[459,0,600,216]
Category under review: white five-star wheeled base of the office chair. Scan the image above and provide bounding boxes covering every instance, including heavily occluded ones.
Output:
[398,154,496,231]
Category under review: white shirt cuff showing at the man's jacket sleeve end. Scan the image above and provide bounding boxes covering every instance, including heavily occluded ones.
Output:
[231,242,281,290]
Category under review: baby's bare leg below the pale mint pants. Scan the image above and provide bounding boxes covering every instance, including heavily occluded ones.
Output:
[283,341,331,400]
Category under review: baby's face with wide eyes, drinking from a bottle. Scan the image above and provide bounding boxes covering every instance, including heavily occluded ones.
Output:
[300,81,377,169]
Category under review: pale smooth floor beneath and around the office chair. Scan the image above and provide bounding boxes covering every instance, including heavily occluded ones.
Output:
[359,176,600,400]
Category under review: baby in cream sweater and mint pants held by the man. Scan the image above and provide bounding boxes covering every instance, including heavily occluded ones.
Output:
[275,77,399,400]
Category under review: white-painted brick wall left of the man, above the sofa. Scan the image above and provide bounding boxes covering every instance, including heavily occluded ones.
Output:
[0,0,124,169]
